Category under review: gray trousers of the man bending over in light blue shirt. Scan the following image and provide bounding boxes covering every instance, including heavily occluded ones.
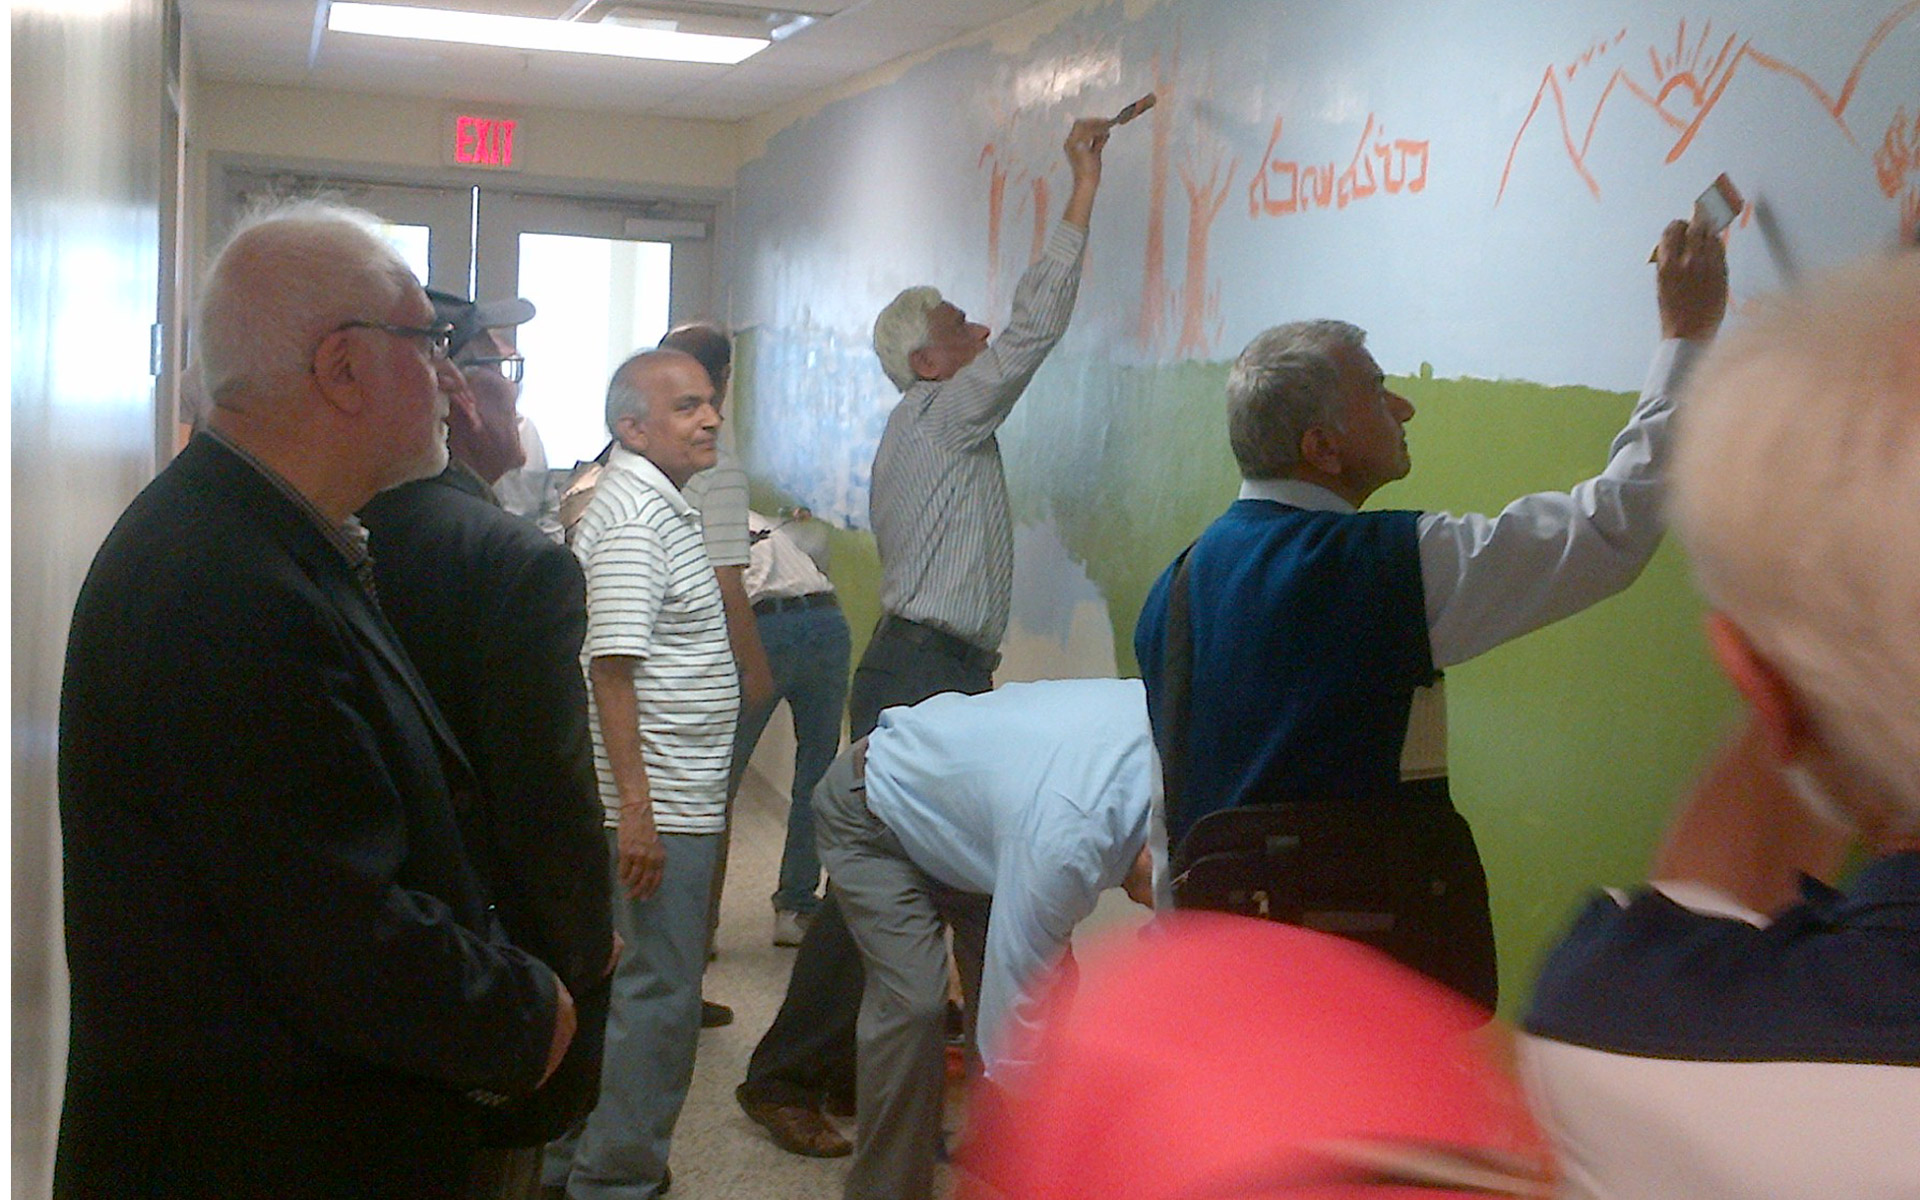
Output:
[814,741,987,1200]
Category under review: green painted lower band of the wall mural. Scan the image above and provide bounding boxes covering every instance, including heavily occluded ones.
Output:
[735,339,1734,1016]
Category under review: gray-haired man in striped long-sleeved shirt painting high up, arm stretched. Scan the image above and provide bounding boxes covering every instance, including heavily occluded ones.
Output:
[737,117,1112,1154]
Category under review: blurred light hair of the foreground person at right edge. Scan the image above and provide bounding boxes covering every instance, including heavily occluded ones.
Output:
[1668,253,1920,828]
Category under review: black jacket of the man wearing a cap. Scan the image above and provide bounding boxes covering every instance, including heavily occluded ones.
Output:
[361,463,612,1144]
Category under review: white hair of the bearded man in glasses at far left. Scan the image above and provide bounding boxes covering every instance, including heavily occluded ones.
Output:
[194,200,419,405]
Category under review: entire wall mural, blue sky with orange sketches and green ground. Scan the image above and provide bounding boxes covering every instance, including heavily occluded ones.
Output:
[732,0,1920,996]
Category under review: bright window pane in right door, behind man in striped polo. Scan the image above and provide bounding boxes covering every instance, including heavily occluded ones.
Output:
[518,234,674,468]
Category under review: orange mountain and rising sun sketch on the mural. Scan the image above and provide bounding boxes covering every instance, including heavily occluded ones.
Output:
[1494,0,1920,242]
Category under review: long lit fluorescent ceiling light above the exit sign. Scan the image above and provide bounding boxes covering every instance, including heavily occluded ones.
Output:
[326,0,770,63]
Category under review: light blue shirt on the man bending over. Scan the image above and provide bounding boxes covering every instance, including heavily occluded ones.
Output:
[866,680,1160,1073]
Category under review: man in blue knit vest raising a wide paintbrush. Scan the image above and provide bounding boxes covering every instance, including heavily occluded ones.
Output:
[1133,221,1726,998]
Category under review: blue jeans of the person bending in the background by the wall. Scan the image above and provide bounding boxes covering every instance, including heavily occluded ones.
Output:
[730,605,852,914]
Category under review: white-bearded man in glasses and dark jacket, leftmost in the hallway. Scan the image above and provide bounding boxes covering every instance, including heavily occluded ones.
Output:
[56,204,574,1198]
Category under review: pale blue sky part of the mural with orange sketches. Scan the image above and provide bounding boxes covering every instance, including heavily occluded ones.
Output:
[735,0,1920,526]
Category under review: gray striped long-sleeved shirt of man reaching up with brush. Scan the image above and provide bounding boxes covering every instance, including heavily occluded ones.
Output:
[868,221,1087,651]
